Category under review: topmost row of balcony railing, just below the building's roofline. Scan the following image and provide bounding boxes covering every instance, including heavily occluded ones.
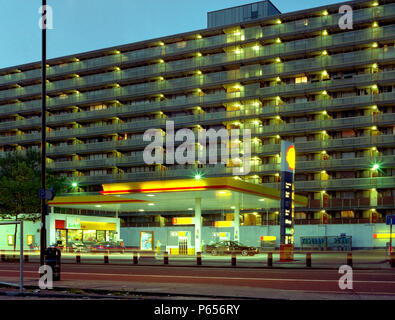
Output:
[0,4,395,89]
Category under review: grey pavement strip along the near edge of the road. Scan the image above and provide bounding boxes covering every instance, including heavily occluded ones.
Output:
[1,279,395,300]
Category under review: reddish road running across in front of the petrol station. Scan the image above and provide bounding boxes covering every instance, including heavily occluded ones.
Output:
[0,263,395,299]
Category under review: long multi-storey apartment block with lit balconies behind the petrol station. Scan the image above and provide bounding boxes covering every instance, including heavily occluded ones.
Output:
[0,0,395,232]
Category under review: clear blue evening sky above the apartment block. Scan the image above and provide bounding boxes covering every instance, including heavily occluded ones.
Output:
[0,0,340,69]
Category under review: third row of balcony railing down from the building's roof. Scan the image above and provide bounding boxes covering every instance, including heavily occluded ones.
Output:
[0,43,395,119]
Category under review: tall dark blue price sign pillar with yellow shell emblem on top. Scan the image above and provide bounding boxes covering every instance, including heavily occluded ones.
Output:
[280,141,296,261]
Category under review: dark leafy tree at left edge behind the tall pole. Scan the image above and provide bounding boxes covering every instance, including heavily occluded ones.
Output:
[0,150,66,250]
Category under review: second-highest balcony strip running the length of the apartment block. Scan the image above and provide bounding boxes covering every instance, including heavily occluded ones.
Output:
[1,26,395,99]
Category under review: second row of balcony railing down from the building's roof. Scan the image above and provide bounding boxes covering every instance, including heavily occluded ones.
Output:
[1,26,395,99]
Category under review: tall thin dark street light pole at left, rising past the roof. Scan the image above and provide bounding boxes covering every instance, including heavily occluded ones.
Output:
[40,0,47,266]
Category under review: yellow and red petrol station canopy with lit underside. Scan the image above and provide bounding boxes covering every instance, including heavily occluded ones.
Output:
[48,177,307,214]
